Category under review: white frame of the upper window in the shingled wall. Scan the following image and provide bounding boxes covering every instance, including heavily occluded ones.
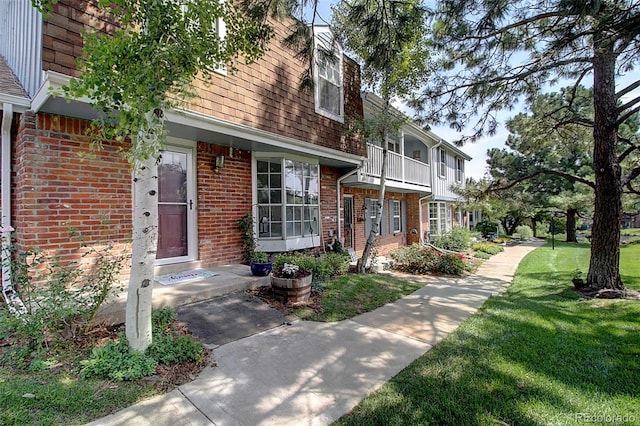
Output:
[313,27,344,123]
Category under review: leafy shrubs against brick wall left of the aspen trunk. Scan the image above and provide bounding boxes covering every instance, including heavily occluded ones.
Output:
[0,235,124,366]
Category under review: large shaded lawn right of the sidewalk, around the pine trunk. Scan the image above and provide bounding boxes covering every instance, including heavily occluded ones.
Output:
[337,243,640,426]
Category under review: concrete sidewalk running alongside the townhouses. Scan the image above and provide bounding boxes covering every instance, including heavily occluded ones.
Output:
[86,241,544,426]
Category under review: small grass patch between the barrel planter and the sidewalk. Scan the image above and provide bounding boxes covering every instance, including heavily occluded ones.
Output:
[291,274,424,321]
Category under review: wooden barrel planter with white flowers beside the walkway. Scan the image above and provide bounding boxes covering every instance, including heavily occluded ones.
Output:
[271,253,315,303]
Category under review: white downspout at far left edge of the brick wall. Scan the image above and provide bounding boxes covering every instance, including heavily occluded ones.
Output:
[0,102,26,315]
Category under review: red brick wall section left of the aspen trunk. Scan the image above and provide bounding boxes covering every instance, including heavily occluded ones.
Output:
[12,112,131,276]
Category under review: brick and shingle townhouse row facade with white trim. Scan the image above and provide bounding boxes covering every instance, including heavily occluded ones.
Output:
[0,0,470,286]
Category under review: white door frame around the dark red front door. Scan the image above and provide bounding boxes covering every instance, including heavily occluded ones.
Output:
[155,137,198,266]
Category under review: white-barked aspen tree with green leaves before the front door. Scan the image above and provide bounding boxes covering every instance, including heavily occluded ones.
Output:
[34,0,272,351]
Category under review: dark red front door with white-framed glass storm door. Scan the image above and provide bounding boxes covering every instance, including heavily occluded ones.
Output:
[156,146,196,265]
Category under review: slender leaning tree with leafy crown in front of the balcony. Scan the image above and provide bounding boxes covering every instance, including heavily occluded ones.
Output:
[333,0,427,272]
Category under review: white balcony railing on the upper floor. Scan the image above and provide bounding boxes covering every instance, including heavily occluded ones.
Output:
[364,144,431,186]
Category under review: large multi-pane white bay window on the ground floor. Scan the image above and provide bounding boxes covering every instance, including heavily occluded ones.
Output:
[256,158,320,239]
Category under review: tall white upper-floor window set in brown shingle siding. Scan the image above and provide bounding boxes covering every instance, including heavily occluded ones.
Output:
[313,28,344,122]
